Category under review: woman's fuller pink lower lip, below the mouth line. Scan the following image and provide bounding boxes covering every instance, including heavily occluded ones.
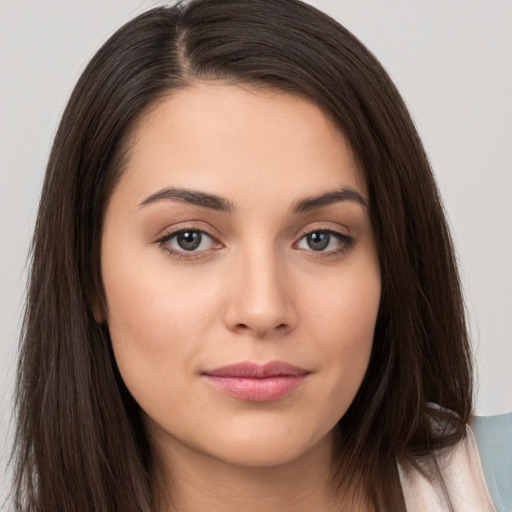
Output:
[204,375,306,402]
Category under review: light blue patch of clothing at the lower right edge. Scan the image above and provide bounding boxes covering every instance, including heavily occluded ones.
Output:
[471,412,512,512]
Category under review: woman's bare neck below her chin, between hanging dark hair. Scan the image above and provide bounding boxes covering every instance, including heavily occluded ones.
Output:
[150,430,370,512]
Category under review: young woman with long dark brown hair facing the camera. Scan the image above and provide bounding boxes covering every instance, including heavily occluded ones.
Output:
[10,0,510,511]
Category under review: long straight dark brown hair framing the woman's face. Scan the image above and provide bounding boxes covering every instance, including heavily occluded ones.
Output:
[13,0,472,512]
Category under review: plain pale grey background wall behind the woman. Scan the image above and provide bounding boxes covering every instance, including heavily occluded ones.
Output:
[0,0,512,503]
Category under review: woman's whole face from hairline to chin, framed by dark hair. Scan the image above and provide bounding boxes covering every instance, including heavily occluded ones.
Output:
[101,83,380,466]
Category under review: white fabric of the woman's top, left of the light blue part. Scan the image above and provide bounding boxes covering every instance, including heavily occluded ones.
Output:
[398,426,496,512]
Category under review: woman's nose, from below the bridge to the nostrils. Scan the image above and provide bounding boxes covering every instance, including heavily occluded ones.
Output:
[224,245,297,338]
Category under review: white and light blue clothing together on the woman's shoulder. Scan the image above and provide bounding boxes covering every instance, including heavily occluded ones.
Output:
[398,413,512,512]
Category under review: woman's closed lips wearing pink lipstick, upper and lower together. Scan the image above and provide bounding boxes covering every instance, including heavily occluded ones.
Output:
[202,361,310,402]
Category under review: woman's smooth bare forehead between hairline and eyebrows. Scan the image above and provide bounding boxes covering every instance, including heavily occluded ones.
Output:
[115,82,366,208]
